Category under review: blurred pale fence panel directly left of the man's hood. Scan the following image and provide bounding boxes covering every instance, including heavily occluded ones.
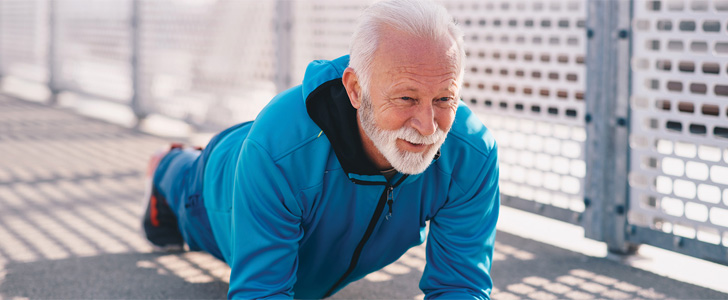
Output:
[139,0,276,128]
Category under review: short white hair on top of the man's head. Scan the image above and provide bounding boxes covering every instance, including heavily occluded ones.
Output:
[349,0,465,93]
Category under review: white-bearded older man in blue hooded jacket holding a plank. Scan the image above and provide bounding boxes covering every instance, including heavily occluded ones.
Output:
[144,0,500,298]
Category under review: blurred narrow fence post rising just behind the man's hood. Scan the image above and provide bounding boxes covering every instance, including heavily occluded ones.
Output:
[273,0,293,93]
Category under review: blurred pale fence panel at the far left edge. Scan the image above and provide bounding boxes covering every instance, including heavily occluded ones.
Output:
[0,0,49,82]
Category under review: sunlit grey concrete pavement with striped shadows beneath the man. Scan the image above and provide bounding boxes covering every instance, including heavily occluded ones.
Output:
[0,96,728,299]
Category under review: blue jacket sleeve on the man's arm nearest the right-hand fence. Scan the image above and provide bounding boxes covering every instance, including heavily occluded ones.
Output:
[420,145,500,299]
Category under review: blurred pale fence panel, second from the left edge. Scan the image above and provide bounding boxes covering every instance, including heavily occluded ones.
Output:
[53,0,133,103]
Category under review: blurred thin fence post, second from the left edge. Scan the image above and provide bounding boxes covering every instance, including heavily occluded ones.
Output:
[129,0,148,127]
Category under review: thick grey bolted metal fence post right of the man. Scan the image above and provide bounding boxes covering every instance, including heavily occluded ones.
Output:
[583,0,637,253]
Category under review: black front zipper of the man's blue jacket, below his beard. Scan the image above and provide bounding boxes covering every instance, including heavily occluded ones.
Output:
[324,175,407,298]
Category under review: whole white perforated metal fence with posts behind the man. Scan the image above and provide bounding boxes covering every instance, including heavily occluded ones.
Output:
[0,0,728,263]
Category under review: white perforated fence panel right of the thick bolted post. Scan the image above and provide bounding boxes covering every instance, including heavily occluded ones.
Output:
[629,0,728,251]
